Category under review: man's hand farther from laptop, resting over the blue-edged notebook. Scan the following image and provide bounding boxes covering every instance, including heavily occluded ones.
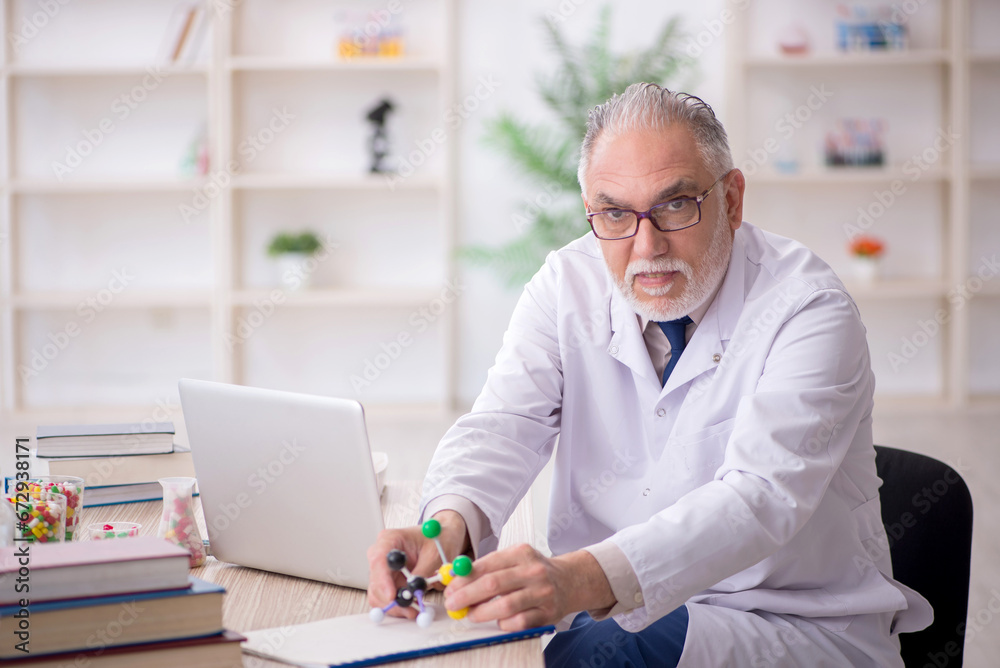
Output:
[445,544,615,631]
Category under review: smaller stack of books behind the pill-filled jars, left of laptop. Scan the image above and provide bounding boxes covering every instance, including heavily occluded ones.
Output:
[13,422,194,507]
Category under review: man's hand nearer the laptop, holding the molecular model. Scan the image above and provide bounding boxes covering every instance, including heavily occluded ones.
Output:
[368,510,469,619]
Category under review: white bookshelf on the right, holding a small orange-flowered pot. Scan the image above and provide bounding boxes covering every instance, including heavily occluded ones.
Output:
[726,0,1000,410]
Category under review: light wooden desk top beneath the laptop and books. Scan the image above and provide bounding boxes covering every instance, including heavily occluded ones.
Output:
[81,482,544,668]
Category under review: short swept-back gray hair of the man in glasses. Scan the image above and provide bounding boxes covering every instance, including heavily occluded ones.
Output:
[577,83,734,195]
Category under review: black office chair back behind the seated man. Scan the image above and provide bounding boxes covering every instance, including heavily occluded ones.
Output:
[875,445,972,668]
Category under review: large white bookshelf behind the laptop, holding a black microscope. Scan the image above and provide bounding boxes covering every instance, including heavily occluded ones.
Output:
[0,0,457,419]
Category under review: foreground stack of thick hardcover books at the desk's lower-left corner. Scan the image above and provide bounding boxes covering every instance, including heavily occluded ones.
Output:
[0,537,244,668]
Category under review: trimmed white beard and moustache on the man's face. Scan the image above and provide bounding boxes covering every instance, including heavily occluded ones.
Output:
[609,215,733,322]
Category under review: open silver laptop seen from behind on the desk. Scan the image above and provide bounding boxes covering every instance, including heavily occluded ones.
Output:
[178,378,383,589]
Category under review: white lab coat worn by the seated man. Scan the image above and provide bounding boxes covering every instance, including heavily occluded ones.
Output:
[424,223,931,666]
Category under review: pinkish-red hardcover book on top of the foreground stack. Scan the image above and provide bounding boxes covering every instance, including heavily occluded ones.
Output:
[0,536,189,605]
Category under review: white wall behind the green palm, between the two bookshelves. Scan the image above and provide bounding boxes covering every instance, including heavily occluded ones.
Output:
[457,0,726,402]
